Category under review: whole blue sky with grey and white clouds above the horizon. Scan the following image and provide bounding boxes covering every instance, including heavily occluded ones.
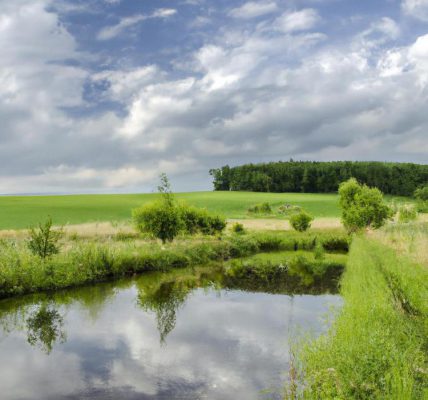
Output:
[0,0,428,194]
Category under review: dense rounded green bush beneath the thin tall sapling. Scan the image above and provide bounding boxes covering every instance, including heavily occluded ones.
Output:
[132,201,182,243]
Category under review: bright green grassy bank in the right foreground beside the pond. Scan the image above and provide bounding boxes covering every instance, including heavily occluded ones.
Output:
[288,237,428,400]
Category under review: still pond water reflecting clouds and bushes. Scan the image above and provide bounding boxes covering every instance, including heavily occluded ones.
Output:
[0,268,340,400]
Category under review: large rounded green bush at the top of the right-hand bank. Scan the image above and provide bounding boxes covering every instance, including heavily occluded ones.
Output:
[339,178,393,232]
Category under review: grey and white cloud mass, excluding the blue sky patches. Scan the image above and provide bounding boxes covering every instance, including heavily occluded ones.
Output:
[0,0,428,193]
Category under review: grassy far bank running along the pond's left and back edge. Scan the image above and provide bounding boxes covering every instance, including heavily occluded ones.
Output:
[0,232,348,298]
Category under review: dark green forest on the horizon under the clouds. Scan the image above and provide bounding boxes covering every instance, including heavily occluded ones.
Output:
[210,160,428,196]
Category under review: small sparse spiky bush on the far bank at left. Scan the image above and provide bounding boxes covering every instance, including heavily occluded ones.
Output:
[27,217,63,259]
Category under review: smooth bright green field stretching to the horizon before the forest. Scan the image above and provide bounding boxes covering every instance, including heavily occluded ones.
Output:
[0,192,412,229]
